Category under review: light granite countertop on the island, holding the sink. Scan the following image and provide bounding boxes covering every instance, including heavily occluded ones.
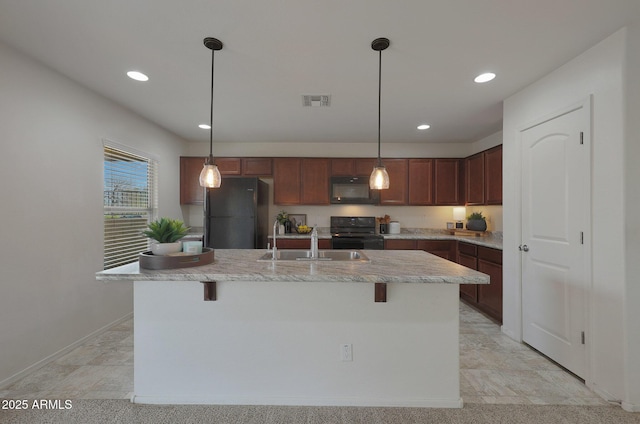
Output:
[96,249,489,284]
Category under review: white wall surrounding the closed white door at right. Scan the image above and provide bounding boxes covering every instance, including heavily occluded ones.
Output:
[503,30,640,406]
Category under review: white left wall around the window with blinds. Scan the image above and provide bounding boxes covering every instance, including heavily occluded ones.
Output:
[0,44,184,386]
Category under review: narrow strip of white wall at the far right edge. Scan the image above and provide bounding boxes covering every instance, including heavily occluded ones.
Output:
[623,22,640,412]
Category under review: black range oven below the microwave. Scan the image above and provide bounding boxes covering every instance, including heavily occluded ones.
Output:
[331,216,384,250]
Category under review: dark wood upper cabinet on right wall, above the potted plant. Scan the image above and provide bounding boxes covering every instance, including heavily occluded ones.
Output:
[465,145,502,205]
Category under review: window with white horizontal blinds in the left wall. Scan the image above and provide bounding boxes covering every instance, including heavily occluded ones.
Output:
[104,144,157,269]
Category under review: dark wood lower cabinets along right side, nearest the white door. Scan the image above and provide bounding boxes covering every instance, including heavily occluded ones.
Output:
[457,242,502,323]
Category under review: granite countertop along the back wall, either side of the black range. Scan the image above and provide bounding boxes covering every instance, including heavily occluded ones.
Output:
[269,228,502,252]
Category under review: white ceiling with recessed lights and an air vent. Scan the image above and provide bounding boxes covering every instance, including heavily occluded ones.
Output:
[0,0,640,143]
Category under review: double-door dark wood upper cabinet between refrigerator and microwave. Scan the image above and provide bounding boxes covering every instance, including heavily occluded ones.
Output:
[273,158,329,205]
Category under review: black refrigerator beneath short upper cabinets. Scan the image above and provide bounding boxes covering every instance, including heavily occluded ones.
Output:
[204,177,269,249]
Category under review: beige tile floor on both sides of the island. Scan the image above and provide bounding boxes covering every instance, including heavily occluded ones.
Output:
[0,302,607,405]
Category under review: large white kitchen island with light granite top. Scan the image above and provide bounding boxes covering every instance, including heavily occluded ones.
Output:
[97,250,489,407]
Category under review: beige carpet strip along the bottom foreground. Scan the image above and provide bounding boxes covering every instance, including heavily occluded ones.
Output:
[0,400,640,424]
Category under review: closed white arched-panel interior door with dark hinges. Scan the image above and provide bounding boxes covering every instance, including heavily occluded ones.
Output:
[521,102,591,378]
